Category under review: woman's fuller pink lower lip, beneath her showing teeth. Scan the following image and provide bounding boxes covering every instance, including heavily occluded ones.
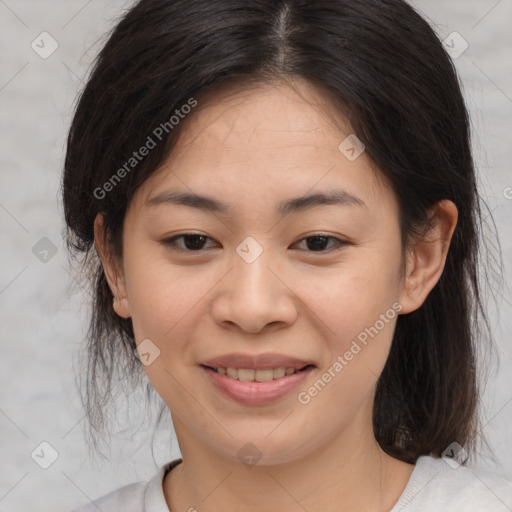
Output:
[201,366,314,405]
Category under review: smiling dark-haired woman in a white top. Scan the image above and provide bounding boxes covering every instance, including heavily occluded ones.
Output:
[63,0,512,512]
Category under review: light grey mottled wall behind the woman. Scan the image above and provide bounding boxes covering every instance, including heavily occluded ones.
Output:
[0,0,512,512]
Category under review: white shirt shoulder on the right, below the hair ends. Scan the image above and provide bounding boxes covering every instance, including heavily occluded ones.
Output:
[391,456,512,512]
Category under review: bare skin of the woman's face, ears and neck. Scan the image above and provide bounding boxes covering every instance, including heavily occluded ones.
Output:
[95,80,457,512]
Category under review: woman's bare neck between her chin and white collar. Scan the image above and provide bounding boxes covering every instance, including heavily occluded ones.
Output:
[164,410,414,512]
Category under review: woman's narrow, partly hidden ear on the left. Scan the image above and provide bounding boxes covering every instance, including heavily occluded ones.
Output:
[94,213,131,318]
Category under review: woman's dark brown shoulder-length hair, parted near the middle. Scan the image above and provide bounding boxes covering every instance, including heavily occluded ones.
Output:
[62,0,502,462]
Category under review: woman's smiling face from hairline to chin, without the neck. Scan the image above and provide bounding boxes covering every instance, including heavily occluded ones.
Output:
[99,81,420,464]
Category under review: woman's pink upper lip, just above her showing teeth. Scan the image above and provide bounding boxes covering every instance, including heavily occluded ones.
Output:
[202,353,313,370]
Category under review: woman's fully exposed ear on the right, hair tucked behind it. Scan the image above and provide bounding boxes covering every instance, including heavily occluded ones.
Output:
[399,199,458,314]
